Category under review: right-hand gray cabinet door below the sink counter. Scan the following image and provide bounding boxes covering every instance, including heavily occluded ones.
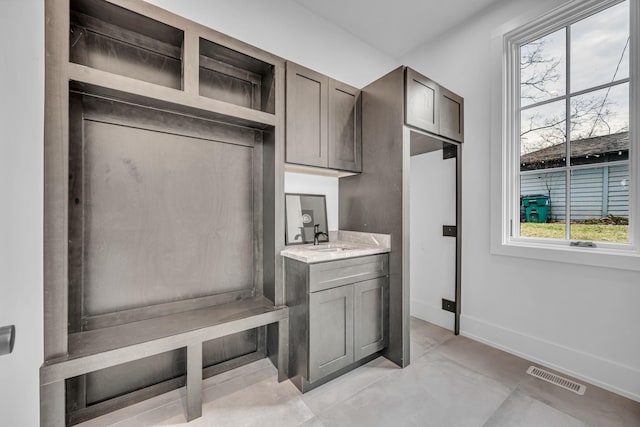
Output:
[353,277,389,360]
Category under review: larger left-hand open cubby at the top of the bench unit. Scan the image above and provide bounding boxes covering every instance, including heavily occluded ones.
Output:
[69,0,184,89]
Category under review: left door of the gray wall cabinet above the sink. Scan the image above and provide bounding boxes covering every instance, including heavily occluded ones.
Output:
[286,62,329,168]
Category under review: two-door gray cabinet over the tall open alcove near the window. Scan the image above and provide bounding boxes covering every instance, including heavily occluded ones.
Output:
[405,67,464,142]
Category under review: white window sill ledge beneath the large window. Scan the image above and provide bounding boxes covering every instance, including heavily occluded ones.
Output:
[491,240,640,271]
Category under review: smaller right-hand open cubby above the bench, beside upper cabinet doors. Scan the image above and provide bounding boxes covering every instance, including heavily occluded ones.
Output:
[199,38,275,114]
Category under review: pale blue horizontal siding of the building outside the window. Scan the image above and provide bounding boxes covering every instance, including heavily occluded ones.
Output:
[520,165,629,221]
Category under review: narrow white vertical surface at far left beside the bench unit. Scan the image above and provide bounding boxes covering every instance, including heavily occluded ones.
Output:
[0,0,44,426]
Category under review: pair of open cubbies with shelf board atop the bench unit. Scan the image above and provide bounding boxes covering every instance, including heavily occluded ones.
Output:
[68,0,277,129]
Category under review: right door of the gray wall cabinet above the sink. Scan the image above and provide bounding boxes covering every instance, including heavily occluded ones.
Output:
[329,79,362,172]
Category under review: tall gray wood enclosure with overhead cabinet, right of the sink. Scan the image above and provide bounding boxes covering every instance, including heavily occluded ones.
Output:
[339,67,464,367]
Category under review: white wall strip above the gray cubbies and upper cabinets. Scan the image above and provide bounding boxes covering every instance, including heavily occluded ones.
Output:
[148,0,397,87]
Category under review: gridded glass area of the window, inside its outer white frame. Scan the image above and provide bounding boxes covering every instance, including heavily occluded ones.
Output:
[514,0,631,244]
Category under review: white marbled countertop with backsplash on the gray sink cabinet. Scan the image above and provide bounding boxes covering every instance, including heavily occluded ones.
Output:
[280,230,391,264]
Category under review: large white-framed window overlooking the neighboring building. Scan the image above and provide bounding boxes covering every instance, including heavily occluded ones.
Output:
[499,0,640,268]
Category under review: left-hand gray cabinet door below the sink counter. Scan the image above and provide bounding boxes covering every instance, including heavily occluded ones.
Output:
[308,285,354,382]
